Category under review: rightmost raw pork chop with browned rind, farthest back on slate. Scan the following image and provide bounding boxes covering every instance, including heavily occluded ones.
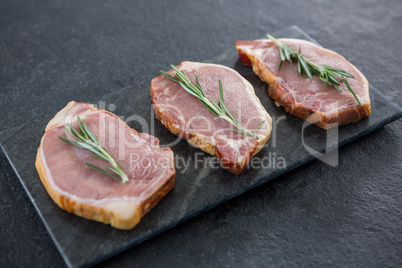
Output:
[236,39,371,129]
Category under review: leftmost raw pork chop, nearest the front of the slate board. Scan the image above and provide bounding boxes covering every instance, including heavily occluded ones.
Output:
[36,101,176,229]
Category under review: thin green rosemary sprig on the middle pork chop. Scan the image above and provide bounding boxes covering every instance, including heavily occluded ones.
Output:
[161,65,265,139]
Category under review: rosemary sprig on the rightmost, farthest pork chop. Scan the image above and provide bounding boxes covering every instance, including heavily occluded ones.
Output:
[267,34,362,106]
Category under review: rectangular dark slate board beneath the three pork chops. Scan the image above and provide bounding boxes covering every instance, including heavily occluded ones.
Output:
[2,26,402,267]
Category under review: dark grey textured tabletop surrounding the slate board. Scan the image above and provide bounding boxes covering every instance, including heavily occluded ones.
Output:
[0,0,402,267]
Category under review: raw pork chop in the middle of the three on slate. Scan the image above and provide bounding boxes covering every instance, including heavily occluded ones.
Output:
[151,62,272,174]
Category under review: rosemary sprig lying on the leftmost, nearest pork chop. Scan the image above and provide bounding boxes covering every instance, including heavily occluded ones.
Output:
[59,116,128,183]
